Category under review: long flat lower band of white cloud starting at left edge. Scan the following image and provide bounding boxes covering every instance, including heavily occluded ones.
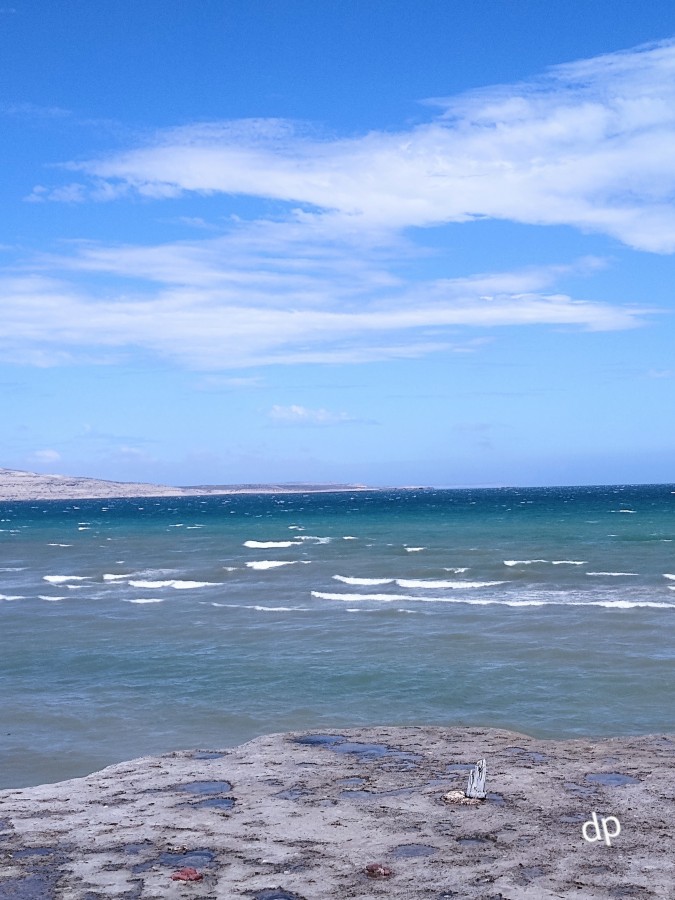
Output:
[0,258,645,370]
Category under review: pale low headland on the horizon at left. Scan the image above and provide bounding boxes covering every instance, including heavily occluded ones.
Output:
[0,468,370,502]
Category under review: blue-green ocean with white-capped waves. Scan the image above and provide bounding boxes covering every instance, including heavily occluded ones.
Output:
[0,485,675,787]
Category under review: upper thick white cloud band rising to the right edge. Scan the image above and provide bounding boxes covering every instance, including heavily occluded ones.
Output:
[39,41,675,253]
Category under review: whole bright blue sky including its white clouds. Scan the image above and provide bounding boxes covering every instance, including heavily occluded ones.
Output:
[0,0,675,487]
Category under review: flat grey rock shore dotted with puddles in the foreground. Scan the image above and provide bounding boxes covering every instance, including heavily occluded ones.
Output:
[0,727,675,900]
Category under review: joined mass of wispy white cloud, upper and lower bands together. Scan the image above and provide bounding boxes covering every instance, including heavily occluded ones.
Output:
[0,42,675,371]
